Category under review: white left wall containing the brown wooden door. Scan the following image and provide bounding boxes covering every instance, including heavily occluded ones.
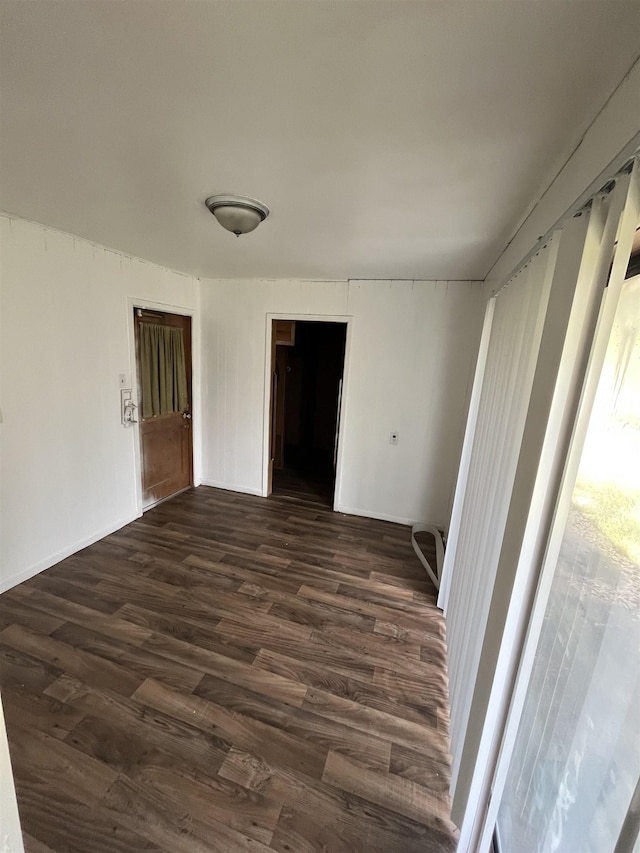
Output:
[0,216,199,590]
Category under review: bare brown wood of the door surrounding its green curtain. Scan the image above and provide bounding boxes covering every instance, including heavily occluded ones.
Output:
[134,308,193,508]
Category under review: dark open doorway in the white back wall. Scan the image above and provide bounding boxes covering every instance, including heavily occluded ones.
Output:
[269,320,347,507]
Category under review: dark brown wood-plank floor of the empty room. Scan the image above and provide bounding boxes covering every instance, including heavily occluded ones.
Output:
[0,487,456,853]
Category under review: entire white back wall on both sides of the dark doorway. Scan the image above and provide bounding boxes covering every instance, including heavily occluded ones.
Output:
[201,280,483,525]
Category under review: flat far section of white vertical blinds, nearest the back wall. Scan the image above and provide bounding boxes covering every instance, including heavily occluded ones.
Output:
[443,237,557,787]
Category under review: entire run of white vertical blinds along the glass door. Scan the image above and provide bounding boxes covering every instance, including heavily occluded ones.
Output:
[439,158,635,851]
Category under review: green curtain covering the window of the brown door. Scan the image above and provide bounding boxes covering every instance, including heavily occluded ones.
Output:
[140,323,189,418]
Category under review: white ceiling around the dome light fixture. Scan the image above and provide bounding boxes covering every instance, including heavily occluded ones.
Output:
[0,0,640,279]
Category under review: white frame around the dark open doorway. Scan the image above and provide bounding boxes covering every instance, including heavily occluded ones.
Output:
[262,311,353,511]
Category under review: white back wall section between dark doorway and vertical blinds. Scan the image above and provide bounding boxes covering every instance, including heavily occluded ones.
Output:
[340,281,482,527]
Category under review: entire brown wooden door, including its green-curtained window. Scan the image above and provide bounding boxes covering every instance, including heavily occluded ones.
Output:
[133,308,193,510]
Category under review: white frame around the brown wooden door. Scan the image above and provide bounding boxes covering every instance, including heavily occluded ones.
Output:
[125,296,202,517]
